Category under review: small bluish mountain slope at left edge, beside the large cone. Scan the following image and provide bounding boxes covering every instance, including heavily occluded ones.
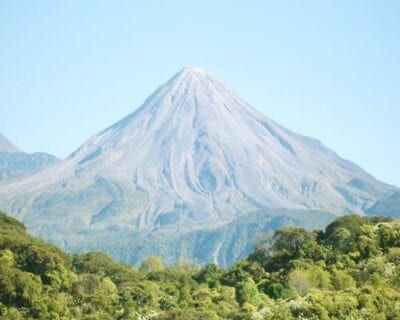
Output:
[0,133,58,183]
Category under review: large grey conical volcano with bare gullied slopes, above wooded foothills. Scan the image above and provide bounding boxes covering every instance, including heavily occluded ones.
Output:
[0,67,396,264]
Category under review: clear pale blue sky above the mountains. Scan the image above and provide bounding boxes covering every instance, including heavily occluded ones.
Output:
[0,0,400,186]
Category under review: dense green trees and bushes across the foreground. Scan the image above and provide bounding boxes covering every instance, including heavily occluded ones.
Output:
[0,214,400,320]
